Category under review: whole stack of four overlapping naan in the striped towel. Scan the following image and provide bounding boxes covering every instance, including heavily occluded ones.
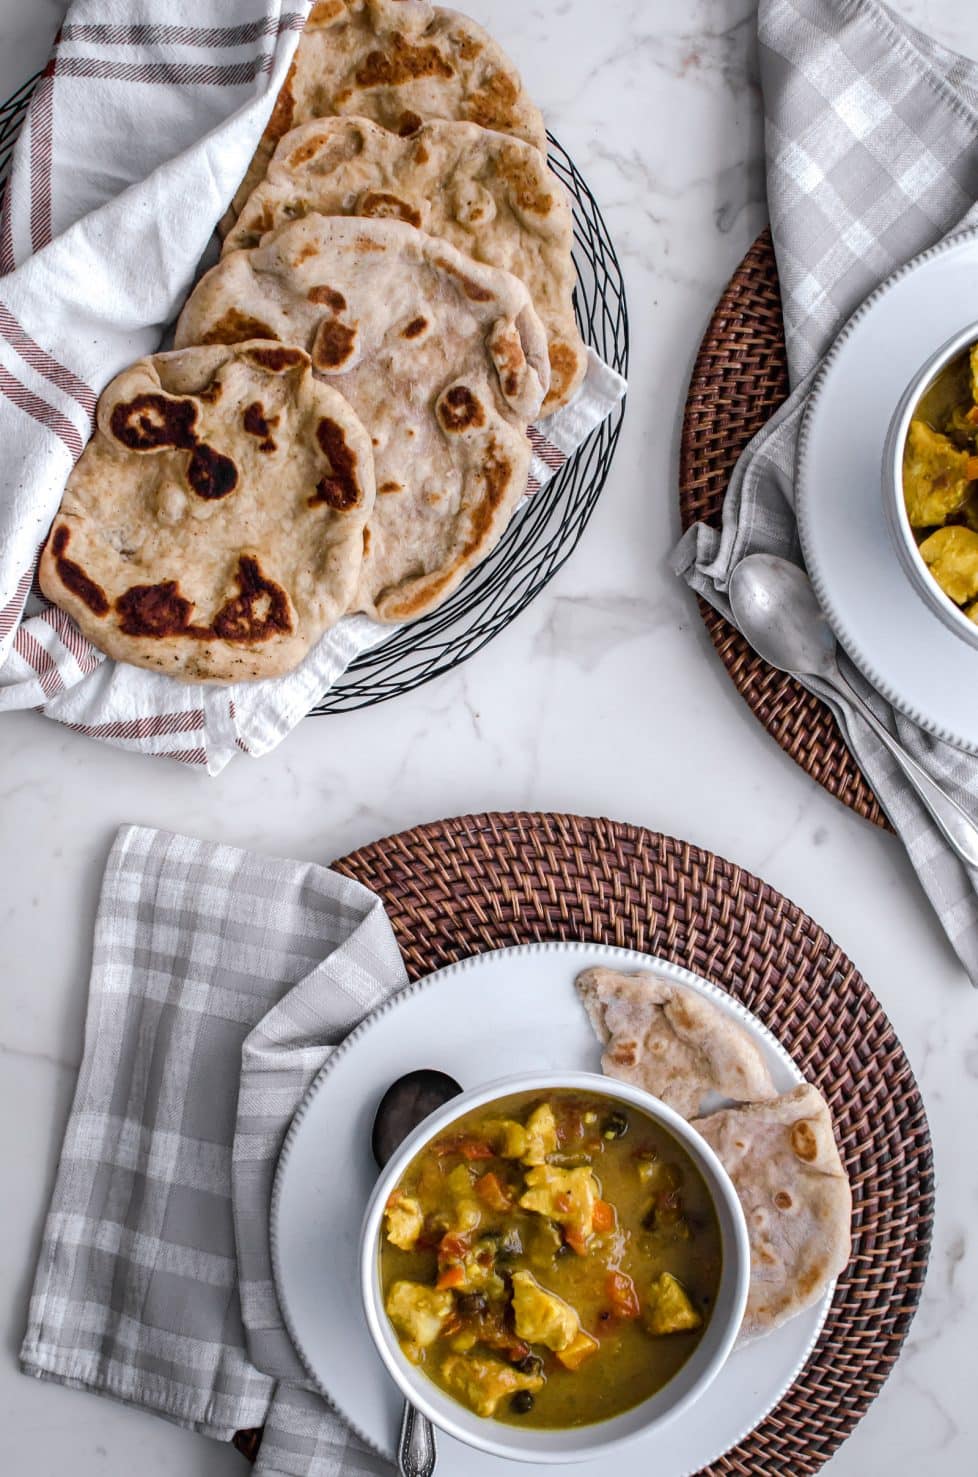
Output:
[40,0,587,682]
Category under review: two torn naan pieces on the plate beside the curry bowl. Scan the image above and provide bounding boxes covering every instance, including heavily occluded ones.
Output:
[578,969,852,1338]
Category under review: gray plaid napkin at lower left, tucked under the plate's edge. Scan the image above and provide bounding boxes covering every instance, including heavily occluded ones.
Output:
[21,826,406,1477]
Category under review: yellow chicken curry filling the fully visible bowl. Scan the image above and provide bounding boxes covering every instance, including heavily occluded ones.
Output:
[381,1092,721,1428]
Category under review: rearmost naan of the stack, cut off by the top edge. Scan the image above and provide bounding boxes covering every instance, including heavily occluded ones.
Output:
[228,0,547,233]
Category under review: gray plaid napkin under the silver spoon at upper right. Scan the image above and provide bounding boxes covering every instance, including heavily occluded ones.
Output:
[674,0,978,985]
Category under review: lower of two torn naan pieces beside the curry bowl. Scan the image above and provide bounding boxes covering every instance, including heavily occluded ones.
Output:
[693,1083,852,1338]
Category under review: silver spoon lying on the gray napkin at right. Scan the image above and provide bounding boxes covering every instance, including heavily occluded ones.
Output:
[728,554,978,867]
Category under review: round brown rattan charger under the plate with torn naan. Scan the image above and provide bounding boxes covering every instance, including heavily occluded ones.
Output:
[236,814,934,1477]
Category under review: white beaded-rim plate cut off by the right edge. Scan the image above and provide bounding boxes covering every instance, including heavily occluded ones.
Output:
[796,230,978,753]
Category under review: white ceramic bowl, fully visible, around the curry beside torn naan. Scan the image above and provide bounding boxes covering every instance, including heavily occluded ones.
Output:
[360,1072,750,1462]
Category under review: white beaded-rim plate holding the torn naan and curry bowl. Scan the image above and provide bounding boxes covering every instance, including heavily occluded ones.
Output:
[272,944,832,1477]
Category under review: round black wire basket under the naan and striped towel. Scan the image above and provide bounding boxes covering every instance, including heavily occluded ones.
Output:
[0,72,628,716]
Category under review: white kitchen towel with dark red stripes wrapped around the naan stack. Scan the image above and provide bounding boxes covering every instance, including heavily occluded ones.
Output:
[0,0,625,774]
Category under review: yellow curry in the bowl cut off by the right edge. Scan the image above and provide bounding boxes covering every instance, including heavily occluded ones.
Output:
[903,346,978,622]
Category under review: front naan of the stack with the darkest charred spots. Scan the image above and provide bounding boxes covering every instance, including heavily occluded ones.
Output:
[40,343,374,682]
